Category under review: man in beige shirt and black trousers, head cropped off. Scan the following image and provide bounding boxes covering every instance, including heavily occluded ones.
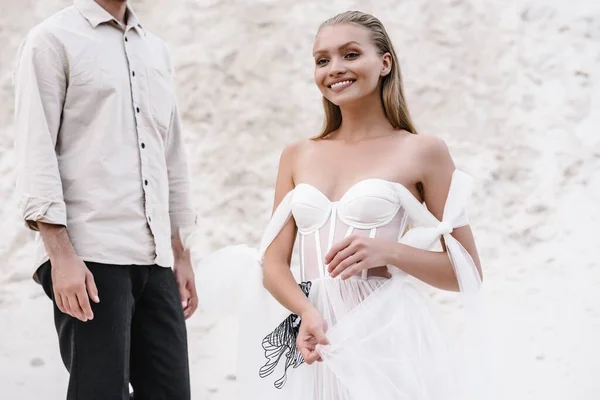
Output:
[15,0,198,400]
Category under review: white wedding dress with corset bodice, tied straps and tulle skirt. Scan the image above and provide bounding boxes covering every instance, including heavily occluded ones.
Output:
[197,170,482,400]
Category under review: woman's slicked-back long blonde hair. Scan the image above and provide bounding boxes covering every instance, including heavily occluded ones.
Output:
[314,11,417,139]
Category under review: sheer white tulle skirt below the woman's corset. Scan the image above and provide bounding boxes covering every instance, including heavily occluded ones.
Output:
[199,246,478,400]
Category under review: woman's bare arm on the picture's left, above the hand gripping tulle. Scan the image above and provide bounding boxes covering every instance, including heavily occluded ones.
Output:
[263,144,313,315]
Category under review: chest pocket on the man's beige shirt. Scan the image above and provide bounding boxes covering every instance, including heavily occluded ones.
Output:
[147,66,174,133]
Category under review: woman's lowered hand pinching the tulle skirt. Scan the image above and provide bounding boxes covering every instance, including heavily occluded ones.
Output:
[296,308,329,365]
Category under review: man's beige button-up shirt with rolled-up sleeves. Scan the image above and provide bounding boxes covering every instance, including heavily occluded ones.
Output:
[14,0,196,276]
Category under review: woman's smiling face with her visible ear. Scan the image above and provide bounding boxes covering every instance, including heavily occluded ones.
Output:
[313,23,392,106]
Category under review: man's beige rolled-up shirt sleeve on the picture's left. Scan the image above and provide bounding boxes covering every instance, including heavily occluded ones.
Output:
[14,30,67,230]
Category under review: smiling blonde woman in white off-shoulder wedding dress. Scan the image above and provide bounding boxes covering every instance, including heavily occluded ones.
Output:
[200,11,482,400]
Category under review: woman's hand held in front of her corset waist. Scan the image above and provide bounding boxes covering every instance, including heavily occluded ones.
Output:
[325,235,396,279]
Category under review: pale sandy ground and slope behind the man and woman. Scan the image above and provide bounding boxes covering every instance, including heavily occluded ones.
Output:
[0,0,600,400]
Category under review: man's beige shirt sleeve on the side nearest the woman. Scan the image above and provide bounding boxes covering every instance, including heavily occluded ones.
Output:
[166,97,197,247]
